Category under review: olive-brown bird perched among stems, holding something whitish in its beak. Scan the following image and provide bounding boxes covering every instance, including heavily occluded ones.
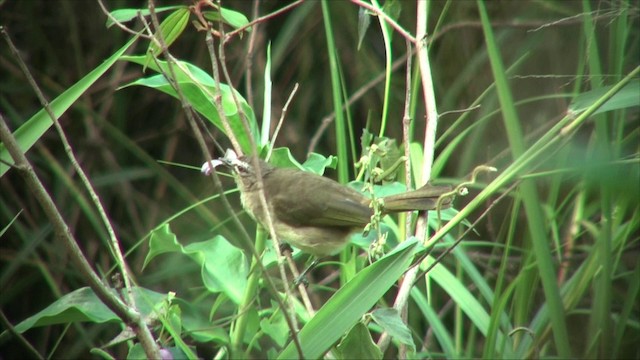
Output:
[202,151,451,257]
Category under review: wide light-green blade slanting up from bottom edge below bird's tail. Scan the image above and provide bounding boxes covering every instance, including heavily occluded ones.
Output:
[278,238,418,359]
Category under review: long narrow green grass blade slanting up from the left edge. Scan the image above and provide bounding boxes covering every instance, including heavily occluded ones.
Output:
[0,38,137,177]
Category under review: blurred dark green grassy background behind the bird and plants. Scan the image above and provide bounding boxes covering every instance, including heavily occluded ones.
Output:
[0,0,640,359]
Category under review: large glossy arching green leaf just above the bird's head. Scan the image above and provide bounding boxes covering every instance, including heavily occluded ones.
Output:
[121,56,259,153]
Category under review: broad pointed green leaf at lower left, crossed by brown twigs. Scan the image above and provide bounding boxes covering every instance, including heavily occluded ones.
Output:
[16,287,167,333]
